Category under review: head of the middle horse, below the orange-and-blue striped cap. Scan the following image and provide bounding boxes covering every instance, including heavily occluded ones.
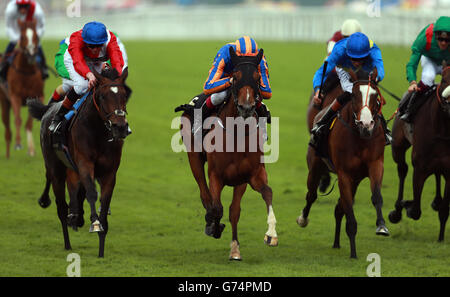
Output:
[230,47,264,119]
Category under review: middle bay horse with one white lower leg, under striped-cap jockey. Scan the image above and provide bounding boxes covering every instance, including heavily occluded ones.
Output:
[180,47,278,260]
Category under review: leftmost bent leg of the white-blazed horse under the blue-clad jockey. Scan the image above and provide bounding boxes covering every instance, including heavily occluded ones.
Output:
[297,157,326,227]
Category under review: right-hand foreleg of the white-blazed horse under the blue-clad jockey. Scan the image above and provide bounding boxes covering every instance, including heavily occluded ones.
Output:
[369,160,389,236]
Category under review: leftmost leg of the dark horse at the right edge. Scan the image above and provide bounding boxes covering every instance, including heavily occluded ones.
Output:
[388,120,411,224]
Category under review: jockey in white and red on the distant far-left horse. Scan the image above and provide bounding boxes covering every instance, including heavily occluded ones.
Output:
[0,0,48,80]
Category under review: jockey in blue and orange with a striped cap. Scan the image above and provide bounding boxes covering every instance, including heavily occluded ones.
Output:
[176,36,272,134]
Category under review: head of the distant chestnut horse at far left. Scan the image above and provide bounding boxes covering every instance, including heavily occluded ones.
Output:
[18,20,39,64]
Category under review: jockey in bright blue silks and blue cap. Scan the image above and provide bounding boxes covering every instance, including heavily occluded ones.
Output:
[311,32,391,146]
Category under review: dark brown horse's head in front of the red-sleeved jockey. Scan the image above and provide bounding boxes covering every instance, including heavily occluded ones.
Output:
[93,68,131,140]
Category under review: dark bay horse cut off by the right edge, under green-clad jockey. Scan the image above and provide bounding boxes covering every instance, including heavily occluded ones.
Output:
[389,62,450,241]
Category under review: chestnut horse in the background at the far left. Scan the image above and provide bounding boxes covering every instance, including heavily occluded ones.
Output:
[1,20,44,158]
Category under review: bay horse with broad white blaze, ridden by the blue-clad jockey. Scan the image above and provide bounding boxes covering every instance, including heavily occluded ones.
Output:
[297,69,389,258]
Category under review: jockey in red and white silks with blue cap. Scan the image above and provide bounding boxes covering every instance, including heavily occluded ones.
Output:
[49,22,126,143]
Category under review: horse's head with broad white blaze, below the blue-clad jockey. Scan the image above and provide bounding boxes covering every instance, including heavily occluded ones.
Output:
[350,68,382,138]
